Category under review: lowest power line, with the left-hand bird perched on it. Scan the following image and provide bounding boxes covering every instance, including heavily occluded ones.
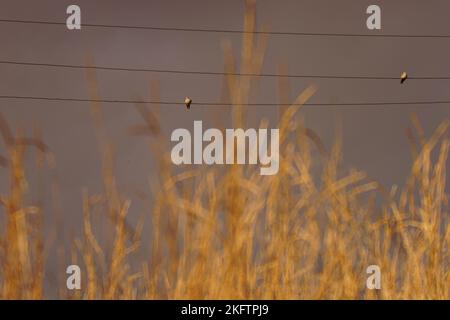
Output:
[0,95,450,107]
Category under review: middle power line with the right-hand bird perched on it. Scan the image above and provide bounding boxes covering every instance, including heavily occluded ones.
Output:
[0,60,450,80]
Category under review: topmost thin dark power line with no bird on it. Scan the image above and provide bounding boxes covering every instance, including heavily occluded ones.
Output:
[0,19,450,39]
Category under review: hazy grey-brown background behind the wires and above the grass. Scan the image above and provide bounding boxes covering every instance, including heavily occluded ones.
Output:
[0,0,450,296]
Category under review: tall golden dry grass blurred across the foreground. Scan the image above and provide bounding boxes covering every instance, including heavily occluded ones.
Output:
[0,1,450,299]
